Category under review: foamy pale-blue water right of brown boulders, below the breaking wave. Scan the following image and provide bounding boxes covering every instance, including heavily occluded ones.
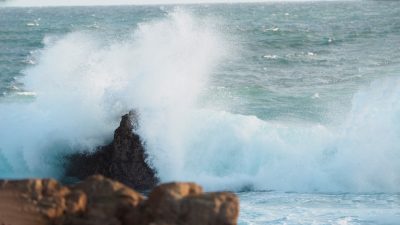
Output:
[239,192,400,225]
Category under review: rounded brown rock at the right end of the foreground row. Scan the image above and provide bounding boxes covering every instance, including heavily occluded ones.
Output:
[136,183,239,225]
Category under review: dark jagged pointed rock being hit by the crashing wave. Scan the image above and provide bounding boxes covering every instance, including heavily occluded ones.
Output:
[65,111,157,190]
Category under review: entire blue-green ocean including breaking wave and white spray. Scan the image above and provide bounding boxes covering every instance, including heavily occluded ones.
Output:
[0,1,400,225]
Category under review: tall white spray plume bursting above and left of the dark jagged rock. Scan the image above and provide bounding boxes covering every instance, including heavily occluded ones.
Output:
[0,8,226,177]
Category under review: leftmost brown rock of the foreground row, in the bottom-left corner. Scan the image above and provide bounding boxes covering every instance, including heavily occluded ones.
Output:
[0,179,70,225]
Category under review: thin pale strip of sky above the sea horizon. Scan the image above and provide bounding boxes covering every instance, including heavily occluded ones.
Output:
[0,0,344,6]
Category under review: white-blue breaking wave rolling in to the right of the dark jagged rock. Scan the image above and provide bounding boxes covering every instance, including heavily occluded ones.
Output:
[141,78,400,192]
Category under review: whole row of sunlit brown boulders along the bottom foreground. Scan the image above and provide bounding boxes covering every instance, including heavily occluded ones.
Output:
[0,175,239,225]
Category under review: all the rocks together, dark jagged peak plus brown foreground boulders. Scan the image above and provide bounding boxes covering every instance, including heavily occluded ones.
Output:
[0,111,239,225]
